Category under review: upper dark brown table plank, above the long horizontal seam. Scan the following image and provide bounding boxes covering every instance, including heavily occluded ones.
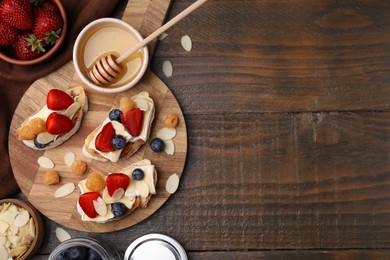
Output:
[152,0,390,114]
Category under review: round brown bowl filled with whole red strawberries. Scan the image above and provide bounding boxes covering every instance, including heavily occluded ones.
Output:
[0,0,67,65]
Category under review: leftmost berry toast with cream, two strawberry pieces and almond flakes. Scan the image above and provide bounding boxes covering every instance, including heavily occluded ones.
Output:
[16,86,88,150]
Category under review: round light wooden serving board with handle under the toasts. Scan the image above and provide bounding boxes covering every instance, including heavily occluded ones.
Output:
[9,0,187,232]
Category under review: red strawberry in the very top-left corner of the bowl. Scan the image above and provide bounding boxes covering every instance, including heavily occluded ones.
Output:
[0,0,34,30]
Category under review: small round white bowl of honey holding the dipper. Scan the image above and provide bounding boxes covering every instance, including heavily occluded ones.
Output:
[73,18,149,93]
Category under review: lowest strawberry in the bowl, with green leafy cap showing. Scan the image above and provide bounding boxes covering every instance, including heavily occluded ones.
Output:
[15,33,45,60]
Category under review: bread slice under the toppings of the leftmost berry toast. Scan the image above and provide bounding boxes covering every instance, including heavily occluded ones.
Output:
[17,86,88,150]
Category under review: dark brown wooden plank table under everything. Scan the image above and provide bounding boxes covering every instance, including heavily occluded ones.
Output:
[23,0,390,259]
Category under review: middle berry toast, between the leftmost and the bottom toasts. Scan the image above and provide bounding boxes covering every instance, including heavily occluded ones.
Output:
[83,91,155,162]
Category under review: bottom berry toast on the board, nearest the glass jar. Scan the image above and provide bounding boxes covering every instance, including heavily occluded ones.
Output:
[77,159,157,223]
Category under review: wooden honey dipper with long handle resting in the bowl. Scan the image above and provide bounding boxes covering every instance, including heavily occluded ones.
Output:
[88,0,207,86]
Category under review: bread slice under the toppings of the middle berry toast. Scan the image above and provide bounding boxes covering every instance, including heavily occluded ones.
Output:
[82,91,155,162]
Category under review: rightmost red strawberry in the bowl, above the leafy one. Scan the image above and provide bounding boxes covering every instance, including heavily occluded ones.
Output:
[33,10,63,39]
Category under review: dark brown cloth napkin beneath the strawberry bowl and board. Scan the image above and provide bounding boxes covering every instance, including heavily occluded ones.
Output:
[0,0,119,198]
